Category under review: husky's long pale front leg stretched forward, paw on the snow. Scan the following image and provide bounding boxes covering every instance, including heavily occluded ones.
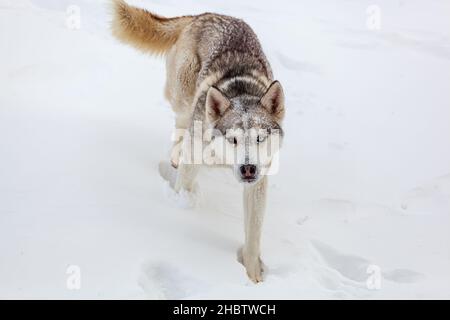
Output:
[240,176,267,283]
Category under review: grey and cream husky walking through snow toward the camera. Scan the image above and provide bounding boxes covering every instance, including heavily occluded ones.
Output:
[112,0,285,282]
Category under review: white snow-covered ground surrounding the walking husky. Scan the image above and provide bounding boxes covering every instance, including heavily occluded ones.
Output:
[0,0,450,299]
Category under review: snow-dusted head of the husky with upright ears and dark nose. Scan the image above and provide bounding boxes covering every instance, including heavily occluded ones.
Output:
[205,81,284,184]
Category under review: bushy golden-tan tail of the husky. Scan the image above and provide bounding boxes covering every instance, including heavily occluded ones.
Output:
[112,0,193,54]
